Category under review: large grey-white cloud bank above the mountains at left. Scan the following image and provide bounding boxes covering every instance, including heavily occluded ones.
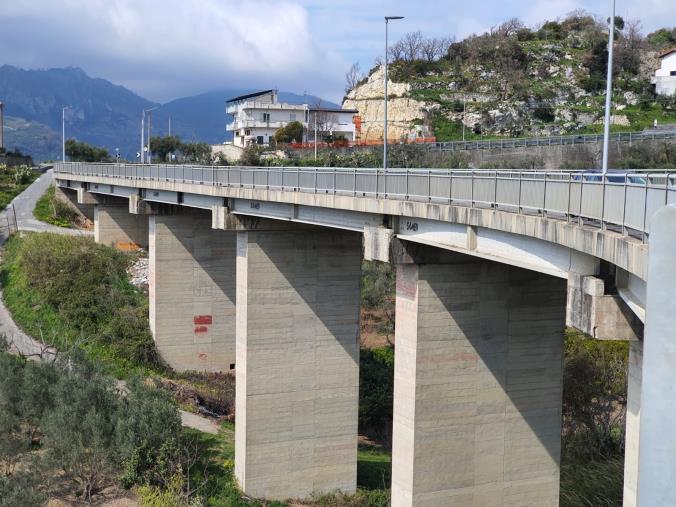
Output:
[0,0,341,102]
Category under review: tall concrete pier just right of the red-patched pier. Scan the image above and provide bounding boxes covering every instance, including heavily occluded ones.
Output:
[235,229,362,499]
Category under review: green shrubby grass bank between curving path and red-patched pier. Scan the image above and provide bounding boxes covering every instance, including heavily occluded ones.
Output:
[0,233,160,378]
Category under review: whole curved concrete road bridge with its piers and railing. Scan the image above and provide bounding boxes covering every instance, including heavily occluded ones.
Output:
[54,163,676,506]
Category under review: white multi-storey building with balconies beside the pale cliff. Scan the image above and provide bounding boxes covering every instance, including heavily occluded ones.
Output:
[225,90,357,148]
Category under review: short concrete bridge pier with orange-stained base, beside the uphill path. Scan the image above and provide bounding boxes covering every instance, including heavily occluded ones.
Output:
[94,199,148,250]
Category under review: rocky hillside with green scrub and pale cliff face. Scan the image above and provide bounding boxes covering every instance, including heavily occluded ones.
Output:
[343,12,676,140]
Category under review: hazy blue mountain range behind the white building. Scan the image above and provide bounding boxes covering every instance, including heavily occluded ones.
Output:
[0,65,336,160]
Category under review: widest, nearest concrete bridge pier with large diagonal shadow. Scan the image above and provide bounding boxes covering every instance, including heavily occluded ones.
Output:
[392,245,566,507]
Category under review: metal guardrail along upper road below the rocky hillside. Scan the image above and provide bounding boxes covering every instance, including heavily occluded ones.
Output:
[428,131,676,151]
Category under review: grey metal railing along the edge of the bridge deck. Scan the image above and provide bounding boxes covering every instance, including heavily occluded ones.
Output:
[55,162,676,240]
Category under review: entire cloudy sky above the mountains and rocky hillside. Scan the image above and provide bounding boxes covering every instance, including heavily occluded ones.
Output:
[0,0,676,102]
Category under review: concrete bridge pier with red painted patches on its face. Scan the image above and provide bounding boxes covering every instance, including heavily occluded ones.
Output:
[149,210,237,372]
